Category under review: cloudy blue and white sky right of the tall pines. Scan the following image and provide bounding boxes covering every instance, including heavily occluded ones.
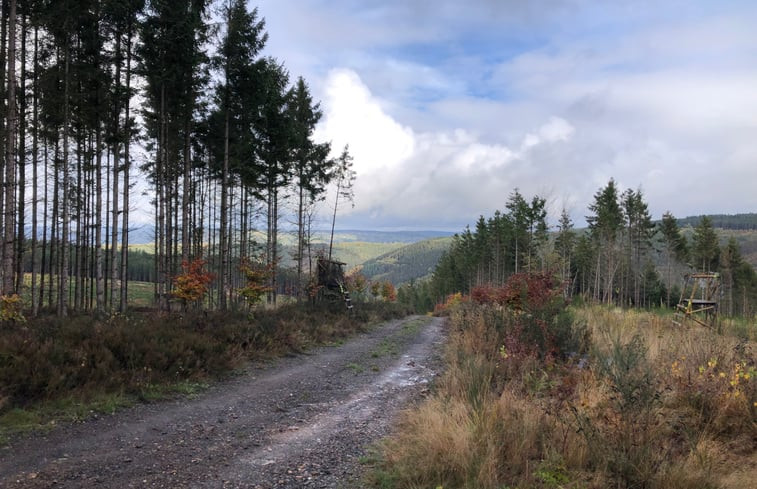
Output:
[250,0,757,231]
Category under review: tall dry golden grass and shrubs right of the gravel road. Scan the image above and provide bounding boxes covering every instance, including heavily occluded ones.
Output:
[366,278,757,489]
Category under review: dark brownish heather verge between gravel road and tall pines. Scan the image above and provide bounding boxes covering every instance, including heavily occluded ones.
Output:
[0,303,408,443]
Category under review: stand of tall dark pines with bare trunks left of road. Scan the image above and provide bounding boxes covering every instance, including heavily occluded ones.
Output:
[0,0,354,316]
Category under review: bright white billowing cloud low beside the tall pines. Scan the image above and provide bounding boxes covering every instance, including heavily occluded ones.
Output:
[317,69,574,228]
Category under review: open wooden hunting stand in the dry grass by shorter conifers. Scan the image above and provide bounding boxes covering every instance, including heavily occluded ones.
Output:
[673,272,720,328]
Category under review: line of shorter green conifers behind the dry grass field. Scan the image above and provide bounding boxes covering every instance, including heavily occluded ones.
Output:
[422,179,757,316]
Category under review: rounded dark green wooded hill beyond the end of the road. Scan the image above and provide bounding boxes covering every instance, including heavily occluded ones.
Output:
[362,237,452,285]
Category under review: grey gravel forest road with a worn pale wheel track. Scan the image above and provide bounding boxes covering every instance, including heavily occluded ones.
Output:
[0,317,444,489]
